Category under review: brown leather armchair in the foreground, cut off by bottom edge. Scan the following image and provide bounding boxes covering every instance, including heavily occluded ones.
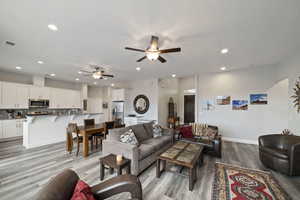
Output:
[35,169,143,200]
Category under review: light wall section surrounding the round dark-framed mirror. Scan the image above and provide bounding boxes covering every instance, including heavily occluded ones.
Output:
[118,79,158,120]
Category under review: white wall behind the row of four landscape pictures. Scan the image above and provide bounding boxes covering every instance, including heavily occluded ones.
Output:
[198,66,289,143]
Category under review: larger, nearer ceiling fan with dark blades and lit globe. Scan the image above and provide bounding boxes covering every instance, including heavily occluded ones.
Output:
[125,36,181,63]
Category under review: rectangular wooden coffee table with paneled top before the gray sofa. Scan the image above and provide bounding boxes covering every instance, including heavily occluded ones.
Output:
[156,141,203,191]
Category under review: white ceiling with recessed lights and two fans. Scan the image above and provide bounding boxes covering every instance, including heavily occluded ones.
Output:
[0,0,300,85]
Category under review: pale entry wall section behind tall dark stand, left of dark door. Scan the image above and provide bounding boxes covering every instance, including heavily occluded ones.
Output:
[158,78,179,127]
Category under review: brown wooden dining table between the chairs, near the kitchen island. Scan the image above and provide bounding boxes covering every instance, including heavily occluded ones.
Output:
[78,123,105,157]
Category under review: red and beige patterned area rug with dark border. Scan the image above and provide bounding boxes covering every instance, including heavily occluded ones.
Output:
[212,163,291,200]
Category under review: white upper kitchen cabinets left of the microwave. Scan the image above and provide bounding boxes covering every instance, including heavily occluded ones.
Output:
[1,82,29,109]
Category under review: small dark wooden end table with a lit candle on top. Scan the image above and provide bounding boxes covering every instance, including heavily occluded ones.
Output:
[99,154,131,181]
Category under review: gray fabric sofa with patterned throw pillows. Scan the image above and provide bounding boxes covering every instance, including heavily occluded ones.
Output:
[103,122,174,175]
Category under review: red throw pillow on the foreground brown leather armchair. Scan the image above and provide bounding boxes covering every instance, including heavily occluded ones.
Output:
[71,180,96,200]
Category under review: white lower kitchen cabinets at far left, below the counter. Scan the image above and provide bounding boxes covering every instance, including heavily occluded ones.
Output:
[1,119,23,138]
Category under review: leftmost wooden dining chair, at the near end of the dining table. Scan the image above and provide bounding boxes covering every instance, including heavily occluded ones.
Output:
[67,123,93,156]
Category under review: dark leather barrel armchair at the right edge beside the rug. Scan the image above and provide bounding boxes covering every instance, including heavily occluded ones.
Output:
[258,134,300,176]
